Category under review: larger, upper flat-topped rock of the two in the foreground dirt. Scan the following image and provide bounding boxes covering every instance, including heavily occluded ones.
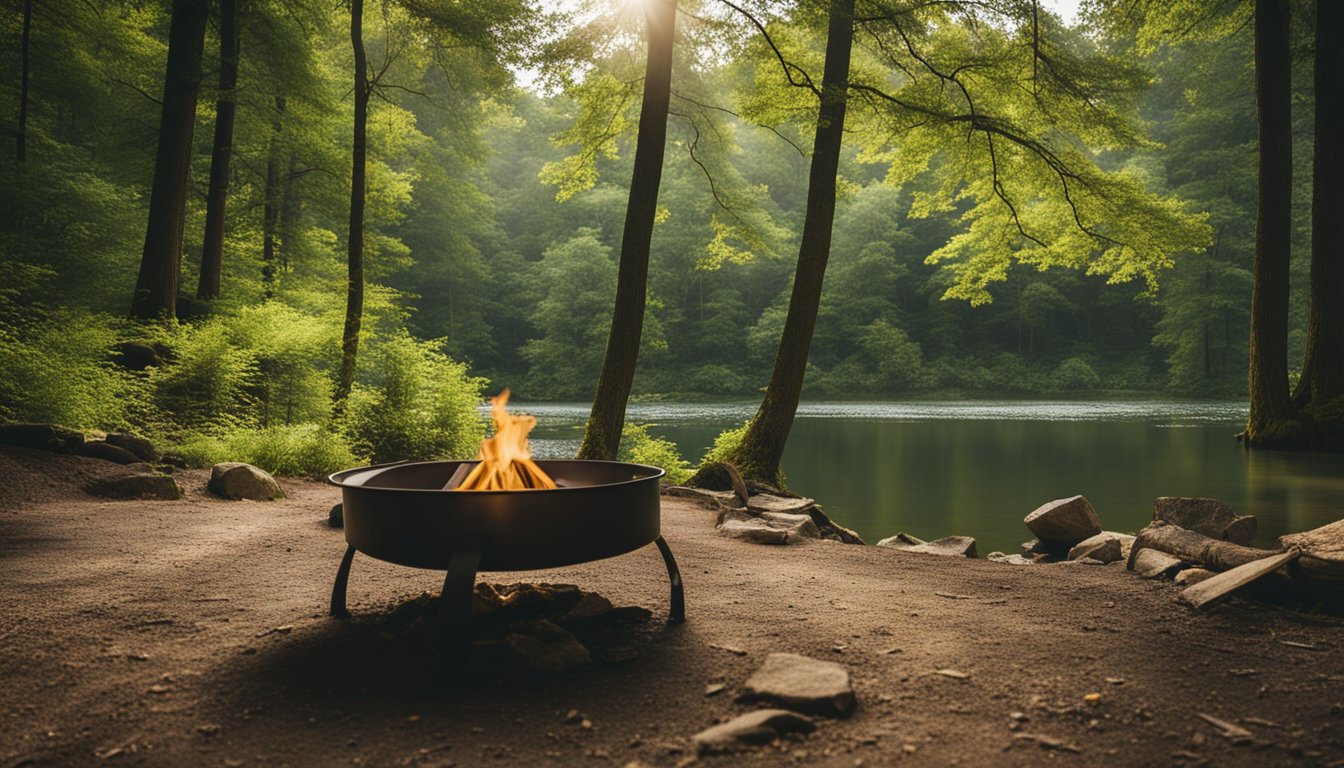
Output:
[739,654,853,717]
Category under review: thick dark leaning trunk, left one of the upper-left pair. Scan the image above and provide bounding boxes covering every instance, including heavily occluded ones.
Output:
[130,0,210,320]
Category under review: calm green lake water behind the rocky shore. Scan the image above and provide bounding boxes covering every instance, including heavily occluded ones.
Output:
[519,401,1344,555]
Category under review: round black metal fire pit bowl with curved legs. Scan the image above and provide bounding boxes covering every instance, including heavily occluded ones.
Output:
[329,461,685,628]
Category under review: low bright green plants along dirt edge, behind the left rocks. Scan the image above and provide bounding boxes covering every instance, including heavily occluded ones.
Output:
[169,424,359,477]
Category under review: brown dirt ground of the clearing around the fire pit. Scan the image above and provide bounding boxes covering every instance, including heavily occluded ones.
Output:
[0,449,1344,768]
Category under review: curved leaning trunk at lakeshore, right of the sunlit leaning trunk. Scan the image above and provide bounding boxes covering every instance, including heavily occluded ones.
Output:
[692,0,853,486]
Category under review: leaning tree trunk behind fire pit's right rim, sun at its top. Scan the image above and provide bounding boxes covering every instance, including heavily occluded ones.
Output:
[578,0,676,460]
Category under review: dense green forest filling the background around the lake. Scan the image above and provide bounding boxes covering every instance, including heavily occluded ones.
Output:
[0,0,1344,479]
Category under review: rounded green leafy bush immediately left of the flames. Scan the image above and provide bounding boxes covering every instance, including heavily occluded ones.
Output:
[341,335,485,464]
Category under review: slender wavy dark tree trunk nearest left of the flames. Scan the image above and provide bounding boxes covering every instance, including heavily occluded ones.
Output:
[335,0,370,412]
